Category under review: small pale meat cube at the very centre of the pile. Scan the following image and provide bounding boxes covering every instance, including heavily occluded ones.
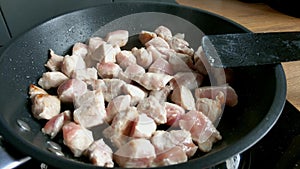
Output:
[122,84,147,106]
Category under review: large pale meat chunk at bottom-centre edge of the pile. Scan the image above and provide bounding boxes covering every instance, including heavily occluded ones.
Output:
[114,138,156,168]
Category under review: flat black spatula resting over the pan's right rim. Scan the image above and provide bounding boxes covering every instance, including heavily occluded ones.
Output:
[202,32,300,68]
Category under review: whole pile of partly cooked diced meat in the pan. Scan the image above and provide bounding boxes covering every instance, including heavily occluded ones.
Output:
[29,26,237,167]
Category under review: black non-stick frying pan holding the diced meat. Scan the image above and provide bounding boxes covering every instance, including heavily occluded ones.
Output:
[0,2,286,168]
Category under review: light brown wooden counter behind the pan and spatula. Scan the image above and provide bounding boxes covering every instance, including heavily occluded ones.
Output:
[177,0,300,110]
